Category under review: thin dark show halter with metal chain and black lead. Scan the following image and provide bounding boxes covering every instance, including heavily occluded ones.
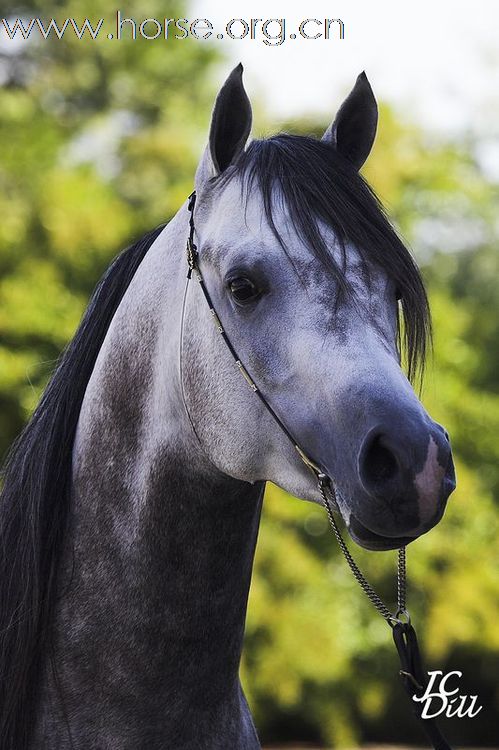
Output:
[187,191,452,750]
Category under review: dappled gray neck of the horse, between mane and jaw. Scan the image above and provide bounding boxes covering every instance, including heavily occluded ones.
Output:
[41,204,262,748]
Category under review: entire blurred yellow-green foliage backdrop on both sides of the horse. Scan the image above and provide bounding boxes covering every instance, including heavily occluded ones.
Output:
[0,8,499,746]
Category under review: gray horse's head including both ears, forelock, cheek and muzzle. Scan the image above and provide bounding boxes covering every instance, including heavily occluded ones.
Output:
[182,66,455,549]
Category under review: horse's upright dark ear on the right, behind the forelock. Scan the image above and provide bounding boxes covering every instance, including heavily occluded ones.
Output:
[322,73,378,169]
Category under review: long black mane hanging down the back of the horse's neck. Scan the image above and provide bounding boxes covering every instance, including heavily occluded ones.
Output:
[0,227,163,750]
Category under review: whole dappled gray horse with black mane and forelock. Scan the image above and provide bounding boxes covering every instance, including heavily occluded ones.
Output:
[0,66,454,750]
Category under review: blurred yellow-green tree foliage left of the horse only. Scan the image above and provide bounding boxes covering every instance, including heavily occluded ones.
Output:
[0,0,217,456]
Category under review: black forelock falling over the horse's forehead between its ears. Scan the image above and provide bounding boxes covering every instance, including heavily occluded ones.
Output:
[219,134,431,380]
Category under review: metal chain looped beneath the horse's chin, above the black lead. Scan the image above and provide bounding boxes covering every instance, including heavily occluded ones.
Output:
[319,475,410,627]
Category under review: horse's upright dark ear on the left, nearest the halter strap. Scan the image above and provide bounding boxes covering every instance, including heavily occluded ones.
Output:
[196,63,252,188]
